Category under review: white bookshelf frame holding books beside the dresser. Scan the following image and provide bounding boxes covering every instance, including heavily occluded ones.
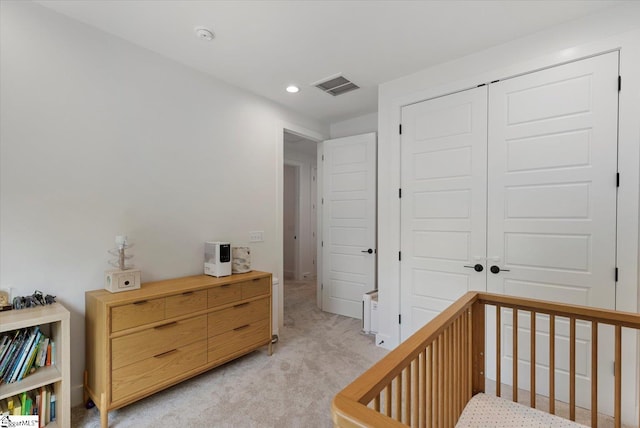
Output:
[0,303,71,428]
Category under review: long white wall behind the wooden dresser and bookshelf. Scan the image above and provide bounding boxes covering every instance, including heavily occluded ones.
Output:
[0,1,328,404]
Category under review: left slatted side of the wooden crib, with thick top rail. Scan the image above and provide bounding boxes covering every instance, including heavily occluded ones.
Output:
[332,293,484,427]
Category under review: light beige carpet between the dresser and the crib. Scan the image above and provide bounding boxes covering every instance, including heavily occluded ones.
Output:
[71,281,387,428]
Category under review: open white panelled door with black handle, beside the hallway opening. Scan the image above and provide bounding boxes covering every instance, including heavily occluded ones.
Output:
[322,133,376,318]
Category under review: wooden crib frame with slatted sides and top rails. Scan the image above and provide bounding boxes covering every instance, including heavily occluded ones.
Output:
[332,292,640,427]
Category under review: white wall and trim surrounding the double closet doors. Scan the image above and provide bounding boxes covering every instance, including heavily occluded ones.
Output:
[376,2,640,420]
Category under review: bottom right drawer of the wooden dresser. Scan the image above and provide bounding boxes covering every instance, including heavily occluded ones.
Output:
[207,319,271,363]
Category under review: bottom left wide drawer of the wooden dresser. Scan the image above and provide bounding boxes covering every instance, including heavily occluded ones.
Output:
[111,339,207,402]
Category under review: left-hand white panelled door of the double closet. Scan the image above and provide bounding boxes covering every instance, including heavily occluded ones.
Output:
[400,87,487,340]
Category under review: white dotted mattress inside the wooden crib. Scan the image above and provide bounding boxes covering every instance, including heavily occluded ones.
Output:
[456,393,585,428]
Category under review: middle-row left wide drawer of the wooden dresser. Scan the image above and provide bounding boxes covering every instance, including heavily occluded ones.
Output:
[111,315,207,370]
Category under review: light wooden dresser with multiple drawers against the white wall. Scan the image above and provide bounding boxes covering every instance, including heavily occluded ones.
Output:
[85,271,272,428]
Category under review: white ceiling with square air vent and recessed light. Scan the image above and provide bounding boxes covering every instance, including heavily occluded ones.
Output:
[38,0,624,123]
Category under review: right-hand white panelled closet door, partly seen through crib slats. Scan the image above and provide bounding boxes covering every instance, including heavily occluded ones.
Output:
[487,52,618,410]
